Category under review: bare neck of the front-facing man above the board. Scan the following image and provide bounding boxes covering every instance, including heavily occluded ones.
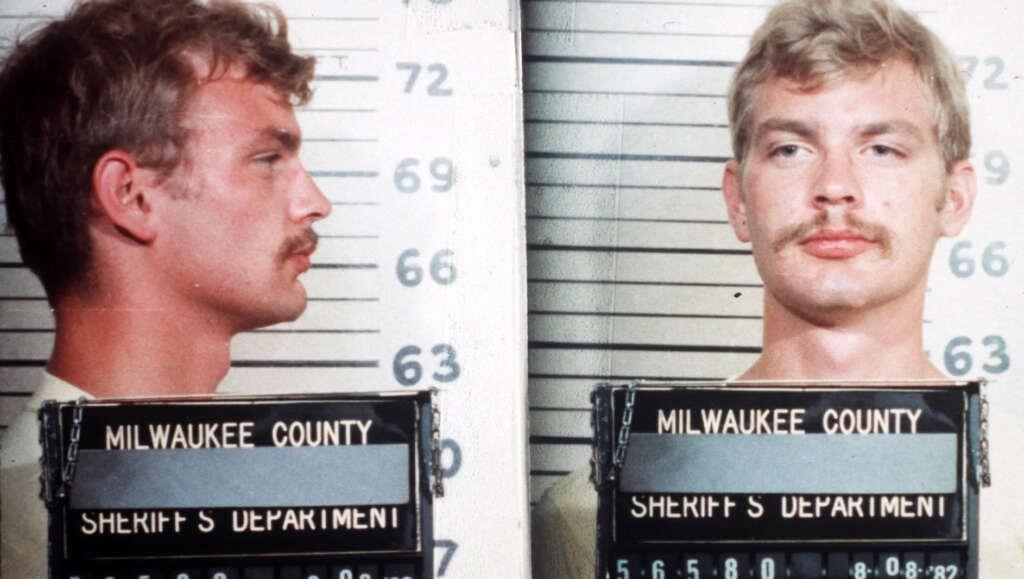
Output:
[739,289,945,380]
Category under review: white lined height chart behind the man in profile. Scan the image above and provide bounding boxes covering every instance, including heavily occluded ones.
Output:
[0,0,528,577]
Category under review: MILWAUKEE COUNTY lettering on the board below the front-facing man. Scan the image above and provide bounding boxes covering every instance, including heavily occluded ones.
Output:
[657,408,922,435]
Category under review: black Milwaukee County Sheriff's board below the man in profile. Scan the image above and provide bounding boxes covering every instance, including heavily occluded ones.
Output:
[41,392,432,574]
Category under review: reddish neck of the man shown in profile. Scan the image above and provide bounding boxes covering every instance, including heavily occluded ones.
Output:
[48,292,231,397]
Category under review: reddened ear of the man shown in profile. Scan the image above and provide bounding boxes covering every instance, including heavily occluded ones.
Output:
[92,150,157,243]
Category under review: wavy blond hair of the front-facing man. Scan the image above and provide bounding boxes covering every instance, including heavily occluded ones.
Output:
[729,0,971,171]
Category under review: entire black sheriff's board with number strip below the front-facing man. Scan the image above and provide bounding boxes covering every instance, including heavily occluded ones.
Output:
[594,382,986,579]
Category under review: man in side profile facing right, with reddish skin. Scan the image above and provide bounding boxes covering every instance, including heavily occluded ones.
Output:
[0,0,331,579]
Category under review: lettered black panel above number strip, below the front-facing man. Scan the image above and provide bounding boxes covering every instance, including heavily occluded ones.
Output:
[614,389,965,542]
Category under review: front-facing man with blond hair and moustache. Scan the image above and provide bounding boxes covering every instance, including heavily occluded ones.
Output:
[534,0,976,579]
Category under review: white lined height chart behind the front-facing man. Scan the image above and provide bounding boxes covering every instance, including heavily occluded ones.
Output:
[523,0,1024,577]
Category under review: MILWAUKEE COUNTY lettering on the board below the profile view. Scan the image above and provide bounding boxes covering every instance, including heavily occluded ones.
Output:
[104,419,373,450]
